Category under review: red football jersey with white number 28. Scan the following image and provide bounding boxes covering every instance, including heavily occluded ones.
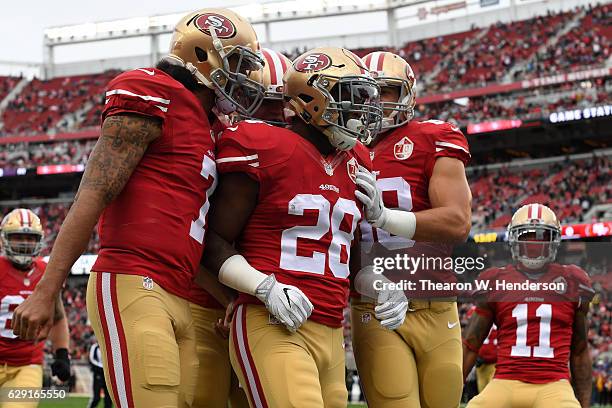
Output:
[217,121,371,327]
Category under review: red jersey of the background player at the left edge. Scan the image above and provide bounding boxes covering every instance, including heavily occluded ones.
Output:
[0,257,47,367]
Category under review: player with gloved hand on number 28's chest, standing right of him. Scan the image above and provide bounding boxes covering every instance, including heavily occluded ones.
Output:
[352,52,471,408]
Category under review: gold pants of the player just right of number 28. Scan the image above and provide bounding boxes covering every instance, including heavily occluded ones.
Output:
[351,301,463,408]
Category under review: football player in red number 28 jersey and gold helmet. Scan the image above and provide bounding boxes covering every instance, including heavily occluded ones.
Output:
[203,48,382,408]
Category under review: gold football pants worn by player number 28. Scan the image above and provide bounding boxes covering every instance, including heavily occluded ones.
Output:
[230,305,348,408]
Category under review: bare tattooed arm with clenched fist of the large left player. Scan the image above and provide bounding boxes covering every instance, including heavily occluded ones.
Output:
[13,114,162,340]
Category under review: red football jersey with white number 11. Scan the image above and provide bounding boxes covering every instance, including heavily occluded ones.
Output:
[476,264,594,384]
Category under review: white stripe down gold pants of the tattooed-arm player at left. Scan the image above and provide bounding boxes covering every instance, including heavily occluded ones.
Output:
[100,272,128,408]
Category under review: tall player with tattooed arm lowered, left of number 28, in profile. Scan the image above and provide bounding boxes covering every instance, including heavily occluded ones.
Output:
[13,9,263,407]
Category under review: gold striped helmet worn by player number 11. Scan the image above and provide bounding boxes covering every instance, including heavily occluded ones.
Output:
[508,204,561,270]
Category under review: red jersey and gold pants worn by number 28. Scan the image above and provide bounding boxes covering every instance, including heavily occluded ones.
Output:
[217,121,371,407]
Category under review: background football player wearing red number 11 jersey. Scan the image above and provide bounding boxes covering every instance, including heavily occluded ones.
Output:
[463,204,594,408]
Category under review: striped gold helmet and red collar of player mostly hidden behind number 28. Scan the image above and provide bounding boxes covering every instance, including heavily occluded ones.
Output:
[246,48,293,126]
